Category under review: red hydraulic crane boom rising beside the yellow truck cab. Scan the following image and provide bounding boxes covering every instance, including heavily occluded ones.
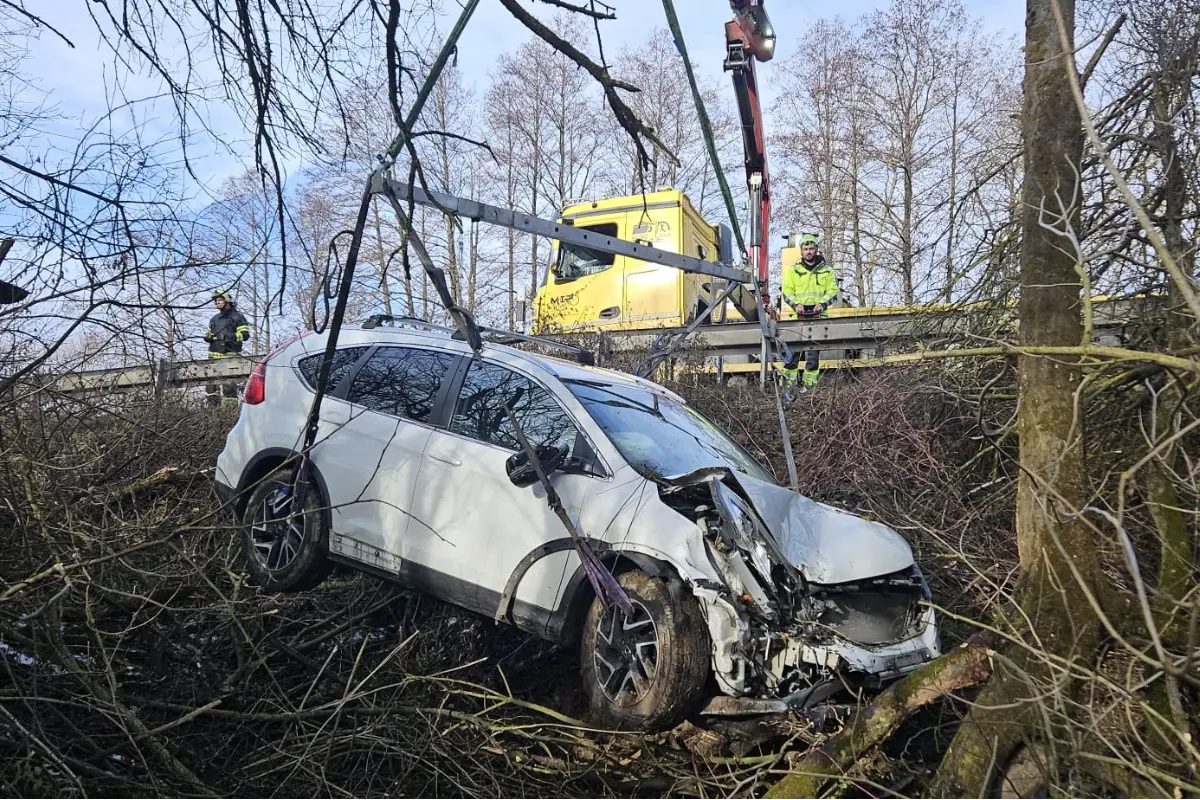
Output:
[725,0,775,315]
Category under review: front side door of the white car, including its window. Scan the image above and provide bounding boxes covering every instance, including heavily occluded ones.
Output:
[409,361,602,633]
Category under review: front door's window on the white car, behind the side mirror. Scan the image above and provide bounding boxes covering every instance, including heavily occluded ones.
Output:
[450,362,578,450]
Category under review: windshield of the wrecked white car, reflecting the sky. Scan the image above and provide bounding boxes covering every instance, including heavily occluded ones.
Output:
[564,380,774,483]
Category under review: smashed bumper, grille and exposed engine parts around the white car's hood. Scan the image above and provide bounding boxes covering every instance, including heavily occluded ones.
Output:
[659,469,938,708]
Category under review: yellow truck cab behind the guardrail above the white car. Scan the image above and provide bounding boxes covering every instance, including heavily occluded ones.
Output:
[534,188,742,335]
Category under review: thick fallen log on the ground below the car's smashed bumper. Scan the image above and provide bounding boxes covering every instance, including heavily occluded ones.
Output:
[766,645,991,798]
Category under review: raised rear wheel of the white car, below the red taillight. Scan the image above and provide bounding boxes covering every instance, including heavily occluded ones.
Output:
[241,468,334,593]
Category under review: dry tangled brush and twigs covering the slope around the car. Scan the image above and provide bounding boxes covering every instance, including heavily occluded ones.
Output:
[0,366,1196,796]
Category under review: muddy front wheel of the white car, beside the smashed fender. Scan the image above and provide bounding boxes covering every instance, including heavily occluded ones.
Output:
[580,570,712,732]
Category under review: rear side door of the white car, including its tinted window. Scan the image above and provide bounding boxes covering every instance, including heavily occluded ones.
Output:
[316,345,458,575]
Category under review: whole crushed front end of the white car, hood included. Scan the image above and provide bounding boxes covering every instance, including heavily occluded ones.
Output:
[655,468,940,712]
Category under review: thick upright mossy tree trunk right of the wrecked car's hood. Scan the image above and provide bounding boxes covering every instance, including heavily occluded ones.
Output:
[1016,0,1098,671]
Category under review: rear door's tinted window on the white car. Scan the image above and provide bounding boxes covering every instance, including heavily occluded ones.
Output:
[348,347,455,422]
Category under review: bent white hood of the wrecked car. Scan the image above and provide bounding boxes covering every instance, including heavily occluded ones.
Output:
[733,473,913,584]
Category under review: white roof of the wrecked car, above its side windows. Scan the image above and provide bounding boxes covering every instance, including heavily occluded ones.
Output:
[292,323,685,403]
